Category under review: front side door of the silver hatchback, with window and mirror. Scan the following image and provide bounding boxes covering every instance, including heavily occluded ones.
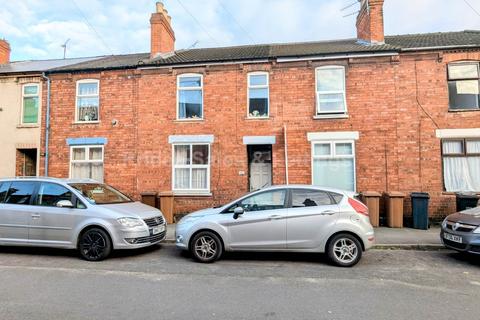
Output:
[222,189,288,250]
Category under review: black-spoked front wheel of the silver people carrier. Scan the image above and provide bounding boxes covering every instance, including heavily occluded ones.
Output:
[78,228,112,261]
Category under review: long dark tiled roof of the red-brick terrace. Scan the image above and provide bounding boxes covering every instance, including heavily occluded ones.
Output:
[47,30,480,72]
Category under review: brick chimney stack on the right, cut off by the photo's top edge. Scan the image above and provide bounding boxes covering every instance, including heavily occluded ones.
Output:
[357,0,385,44]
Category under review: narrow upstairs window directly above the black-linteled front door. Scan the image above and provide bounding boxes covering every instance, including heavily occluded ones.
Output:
[248,72,269,118]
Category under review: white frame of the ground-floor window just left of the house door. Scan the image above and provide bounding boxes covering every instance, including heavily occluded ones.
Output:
[172,142,212,194]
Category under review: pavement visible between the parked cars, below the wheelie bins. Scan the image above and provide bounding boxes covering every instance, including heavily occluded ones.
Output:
[166,224,443,250]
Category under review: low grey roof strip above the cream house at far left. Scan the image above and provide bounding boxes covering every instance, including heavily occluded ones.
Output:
[0,56,103,74]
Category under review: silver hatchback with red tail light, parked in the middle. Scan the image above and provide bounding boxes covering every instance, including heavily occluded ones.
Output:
[175,185,375,267]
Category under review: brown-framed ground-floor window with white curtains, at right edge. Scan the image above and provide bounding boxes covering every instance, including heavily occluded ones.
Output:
[442,139,480,192]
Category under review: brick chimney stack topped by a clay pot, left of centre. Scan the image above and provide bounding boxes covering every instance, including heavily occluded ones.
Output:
[150,2,175,58]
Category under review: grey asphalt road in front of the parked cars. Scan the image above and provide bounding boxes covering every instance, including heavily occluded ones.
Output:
[0,245,480,320]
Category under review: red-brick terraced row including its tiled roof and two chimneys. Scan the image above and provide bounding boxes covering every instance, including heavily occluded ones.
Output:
[42,0,480,218]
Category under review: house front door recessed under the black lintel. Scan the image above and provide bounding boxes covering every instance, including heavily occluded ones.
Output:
[248,145,272,191]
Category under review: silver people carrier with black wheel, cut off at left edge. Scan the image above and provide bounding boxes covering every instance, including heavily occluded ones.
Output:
[0,178,166,261]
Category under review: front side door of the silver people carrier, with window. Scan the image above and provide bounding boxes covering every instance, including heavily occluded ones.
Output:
[29,182,77,246]
